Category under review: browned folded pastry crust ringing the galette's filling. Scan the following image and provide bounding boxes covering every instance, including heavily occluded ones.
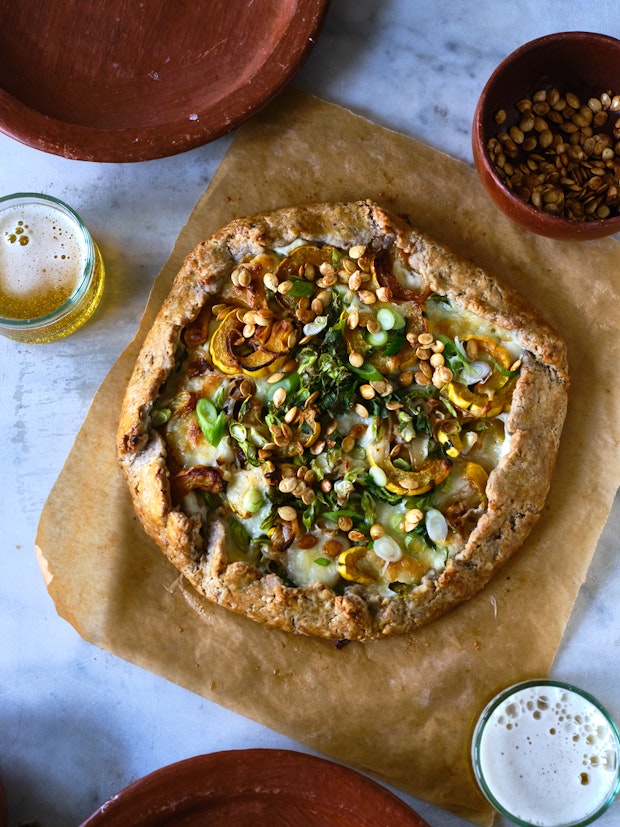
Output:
[117,201,568,640]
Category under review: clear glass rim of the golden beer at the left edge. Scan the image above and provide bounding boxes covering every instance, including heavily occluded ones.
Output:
[0,192,96,330]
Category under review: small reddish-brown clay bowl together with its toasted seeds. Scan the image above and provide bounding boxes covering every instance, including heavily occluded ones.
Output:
[472,32,620,240]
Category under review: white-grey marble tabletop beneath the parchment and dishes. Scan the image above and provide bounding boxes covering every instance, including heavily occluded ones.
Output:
[0,0,620,827]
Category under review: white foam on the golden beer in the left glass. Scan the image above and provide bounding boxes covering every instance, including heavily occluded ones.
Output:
[0,203,87,312]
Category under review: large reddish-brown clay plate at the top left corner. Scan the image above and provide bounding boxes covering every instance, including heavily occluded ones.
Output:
[0,0,329,162]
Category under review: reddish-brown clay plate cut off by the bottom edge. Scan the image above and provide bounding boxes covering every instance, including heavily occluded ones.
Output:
[81,749,428,827]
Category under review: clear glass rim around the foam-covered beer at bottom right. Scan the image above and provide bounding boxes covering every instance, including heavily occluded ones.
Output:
[471,678,620,827]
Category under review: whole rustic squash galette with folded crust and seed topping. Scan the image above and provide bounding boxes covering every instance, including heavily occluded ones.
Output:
[118,201,568,641]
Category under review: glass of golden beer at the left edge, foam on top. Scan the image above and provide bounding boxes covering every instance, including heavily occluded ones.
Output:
[0,193,104,342]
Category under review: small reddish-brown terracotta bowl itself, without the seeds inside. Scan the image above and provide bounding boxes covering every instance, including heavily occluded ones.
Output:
[472,32,620,240]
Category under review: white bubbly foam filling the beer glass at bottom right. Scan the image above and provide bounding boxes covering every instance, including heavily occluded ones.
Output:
[478,685,619,827]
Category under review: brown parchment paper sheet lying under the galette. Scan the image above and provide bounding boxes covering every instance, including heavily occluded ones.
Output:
[37,90,620,825]
